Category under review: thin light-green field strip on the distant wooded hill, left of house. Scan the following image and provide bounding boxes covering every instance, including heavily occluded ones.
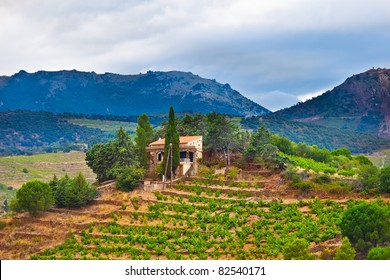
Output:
[68,119,137,136]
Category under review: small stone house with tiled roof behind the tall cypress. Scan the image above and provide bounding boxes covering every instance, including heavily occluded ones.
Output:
[146,136,203,175]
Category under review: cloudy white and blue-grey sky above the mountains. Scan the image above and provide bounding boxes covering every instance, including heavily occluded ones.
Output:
[0,0,390,110]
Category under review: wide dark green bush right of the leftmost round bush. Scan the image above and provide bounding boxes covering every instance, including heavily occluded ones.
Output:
[49,173,96,207]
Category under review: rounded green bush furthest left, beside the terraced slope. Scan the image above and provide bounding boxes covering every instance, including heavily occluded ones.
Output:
[11,180,54,216]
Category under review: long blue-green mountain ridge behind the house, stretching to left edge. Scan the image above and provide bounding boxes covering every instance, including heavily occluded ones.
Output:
[0,70,270,116]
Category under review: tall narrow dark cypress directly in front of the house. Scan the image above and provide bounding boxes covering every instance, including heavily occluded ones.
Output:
[163,107,180,178]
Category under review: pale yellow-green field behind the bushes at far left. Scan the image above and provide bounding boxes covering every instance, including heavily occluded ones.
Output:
[0,151,95,188]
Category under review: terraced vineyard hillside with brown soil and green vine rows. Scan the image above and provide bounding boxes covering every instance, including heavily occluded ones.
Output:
[0,171,386,259]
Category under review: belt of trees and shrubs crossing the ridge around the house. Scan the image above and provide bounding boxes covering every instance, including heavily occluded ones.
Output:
[8,108,390,219]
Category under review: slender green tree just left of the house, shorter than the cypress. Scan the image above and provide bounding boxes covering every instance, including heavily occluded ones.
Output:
[135,114,153,169]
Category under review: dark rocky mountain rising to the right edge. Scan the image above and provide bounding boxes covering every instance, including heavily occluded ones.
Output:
[274,69,390,139]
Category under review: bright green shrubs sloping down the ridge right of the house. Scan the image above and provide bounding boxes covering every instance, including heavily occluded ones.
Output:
[244,127,390,193]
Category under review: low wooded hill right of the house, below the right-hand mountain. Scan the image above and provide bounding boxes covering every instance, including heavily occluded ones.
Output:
[241,115,390,154]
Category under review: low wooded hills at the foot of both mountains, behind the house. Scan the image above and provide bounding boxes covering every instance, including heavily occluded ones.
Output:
[0,110,390,156]
